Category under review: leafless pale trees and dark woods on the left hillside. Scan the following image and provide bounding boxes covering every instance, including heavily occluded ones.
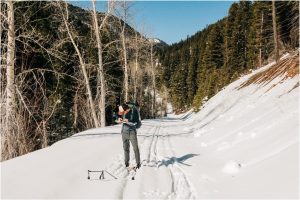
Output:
[0,1,162,160]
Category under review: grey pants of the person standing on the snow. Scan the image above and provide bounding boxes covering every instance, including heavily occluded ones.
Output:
[122,125,140,165]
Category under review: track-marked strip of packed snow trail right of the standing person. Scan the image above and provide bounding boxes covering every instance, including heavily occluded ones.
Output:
[124,121,196,199]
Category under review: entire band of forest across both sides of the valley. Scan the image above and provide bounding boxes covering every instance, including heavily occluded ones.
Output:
[0,1,299,160]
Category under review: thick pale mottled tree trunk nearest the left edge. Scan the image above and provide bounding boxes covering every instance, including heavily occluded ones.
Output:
[5,1,17,158]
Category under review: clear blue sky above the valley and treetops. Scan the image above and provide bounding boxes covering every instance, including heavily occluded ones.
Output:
[70,1,233,44]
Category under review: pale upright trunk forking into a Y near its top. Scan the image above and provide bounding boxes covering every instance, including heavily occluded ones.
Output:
[92,0,110,127]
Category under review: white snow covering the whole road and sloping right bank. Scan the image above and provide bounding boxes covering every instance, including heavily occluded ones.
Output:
[1,55,299,199]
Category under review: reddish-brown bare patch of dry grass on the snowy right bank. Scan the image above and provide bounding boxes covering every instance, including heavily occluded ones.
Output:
[238,52,299,89]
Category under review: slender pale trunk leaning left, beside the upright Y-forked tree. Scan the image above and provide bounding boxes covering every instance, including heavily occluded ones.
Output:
[61,2,99,128]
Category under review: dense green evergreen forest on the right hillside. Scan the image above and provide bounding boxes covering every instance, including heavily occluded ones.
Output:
[160,1,299,112]
